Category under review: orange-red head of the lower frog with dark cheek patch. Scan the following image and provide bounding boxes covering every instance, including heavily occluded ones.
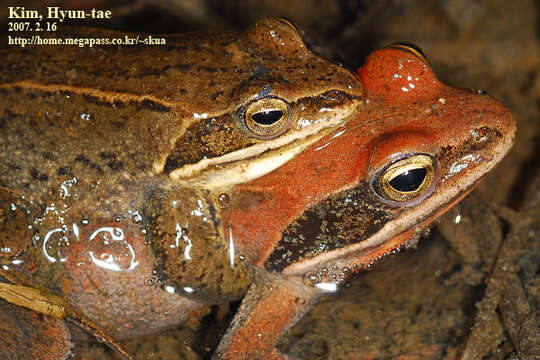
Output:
[224,45,515,282]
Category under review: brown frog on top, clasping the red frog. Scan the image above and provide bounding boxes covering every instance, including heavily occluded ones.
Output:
[0,19,363,356]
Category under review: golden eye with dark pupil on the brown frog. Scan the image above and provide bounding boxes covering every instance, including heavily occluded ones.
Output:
[240,97,290,139]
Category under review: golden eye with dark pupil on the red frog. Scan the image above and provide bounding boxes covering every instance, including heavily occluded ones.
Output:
[376,154,435,202]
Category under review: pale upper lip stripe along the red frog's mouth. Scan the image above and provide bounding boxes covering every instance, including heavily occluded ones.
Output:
[282,134,513,276]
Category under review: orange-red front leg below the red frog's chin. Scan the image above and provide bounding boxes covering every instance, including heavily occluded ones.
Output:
[213,272,322,360]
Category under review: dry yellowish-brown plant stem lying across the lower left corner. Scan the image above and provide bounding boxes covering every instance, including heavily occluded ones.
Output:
[0,269,134,360]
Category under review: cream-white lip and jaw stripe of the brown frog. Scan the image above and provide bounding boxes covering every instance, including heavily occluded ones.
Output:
[169,116,351,190]
